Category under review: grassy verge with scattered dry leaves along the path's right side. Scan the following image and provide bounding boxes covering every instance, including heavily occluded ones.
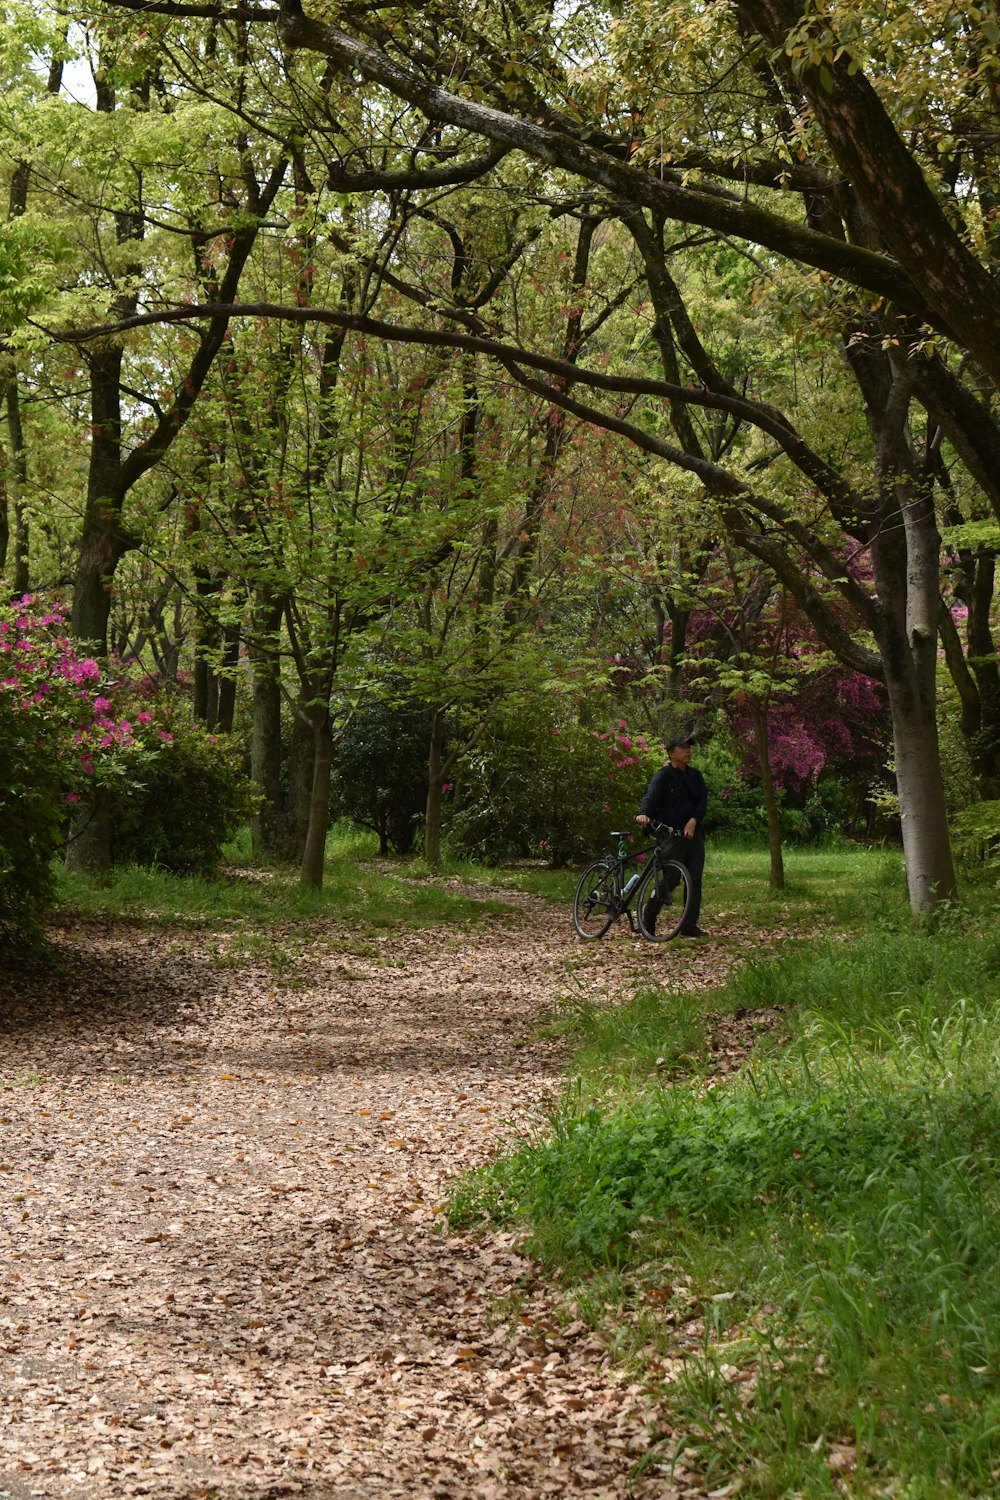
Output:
[450,854,1000,1500]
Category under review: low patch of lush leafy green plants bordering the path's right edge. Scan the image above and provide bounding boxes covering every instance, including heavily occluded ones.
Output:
[456,1068,959,1266]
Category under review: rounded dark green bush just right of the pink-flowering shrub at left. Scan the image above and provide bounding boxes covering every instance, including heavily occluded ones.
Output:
[109,695,255,873]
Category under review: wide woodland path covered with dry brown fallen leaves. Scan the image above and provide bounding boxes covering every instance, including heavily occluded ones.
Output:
[0,890,766,1500]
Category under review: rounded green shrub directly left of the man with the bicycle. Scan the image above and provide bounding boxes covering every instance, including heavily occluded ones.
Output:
[447,696,663,866]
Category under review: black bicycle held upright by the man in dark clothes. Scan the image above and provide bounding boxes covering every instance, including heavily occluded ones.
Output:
[573,822,691,942]
